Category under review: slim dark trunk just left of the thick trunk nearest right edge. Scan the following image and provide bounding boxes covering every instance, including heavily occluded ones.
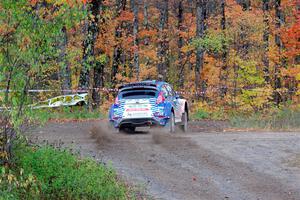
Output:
[263,0,270,84]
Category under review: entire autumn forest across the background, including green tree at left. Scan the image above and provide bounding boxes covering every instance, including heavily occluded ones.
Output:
[0,0,300,199]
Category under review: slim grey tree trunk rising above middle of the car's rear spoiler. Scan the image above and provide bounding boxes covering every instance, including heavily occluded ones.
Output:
[132,0,140,80]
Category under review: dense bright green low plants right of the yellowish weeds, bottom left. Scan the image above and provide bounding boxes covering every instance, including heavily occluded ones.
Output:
[17,147,128,199]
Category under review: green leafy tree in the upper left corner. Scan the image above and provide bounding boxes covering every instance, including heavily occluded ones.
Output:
[0,0,86,125]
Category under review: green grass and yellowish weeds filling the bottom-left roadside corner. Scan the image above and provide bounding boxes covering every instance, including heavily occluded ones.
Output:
[0,142,135,200]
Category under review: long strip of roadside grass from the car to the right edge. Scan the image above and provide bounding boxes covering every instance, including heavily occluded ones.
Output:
[191,104,300,131]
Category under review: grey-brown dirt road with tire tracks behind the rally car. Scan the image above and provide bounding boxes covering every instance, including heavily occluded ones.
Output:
[30,121,300,200]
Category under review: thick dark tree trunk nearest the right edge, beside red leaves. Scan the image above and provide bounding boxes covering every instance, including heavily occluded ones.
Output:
[274,0,283,105]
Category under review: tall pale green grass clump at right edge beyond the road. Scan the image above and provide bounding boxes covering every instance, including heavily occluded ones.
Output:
[230,108,300,131]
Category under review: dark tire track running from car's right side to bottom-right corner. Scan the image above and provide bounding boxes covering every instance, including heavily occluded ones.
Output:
[155,133,300,200]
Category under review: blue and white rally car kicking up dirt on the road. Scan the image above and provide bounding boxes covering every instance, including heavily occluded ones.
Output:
[109,81,189,132]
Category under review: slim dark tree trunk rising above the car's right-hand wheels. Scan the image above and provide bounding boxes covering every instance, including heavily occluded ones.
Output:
[177,0,184,88]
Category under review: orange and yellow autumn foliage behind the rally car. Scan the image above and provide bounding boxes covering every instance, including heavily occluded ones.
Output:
[0,0,300,112]
